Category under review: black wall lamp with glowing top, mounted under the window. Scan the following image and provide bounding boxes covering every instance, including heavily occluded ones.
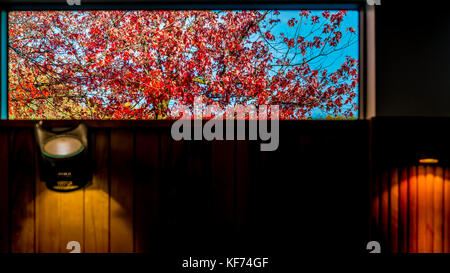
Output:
[35,121,91,192]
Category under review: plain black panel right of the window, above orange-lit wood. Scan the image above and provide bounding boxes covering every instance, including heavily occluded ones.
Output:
[376,1,450,116]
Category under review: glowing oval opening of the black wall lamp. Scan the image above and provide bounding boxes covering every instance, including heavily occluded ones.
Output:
[43,136,84,158]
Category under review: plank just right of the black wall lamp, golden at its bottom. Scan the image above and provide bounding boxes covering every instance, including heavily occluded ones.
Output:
[84,130,109,253]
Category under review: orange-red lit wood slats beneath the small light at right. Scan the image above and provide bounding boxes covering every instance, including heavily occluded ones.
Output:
[371,165,450,253]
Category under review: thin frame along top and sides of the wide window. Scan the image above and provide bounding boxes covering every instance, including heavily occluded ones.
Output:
[0,0,370,121]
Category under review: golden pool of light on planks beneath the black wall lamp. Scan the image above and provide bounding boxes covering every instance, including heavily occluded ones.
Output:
[26,188,133,253]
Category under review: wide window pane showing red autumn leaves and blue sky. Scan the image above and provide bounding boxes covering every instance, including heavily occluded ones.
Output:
[8,10,359,119]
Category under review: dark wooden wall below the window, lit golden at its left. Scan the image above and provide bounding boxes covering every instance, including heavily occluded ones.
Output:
[0,121,368,255]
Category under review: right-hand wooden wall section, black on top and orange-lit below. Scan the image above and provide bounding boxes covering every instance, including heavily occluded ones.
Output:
[370,117,450,253]
